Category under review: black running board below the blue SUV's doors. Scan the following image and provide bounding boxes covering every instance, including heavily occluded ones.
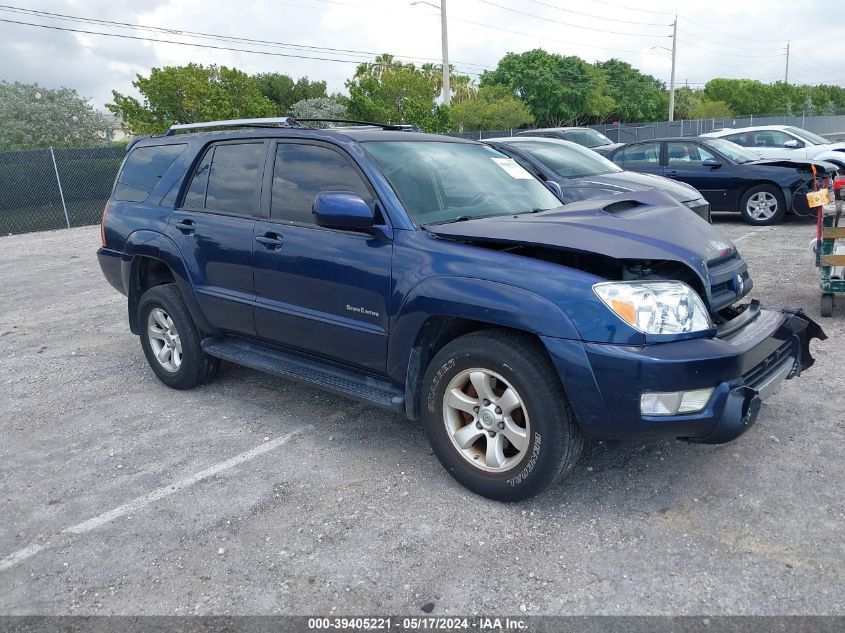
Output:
[202,338,405,413]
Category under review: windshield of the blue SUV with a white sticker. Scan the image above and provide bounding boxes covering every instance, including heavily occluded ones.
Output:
[363,141,561,224]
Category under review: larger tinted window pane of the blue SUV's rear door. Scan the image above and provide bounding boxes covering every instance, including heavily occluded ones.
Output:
[205,143,264,214]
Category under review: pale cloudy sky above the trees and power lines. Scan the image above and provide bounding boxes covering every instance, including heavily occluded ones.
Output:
[0,0,845,109]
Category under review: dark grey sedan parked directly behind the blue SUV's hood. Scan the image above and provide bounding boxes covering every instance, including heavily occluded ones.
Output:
[485,136,710,222]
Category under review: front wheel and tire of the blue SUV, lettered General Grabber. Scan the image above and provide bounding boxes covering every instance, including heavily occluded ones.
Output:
[422,330,583,501]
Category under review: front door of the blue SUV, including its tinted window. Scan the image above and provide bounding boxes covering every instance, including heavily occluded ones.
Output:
[253,141,393,372]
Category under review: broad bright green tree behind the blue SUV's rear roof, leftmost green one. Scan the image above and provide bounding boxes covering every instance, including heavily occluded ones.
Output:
[106,64,277,134]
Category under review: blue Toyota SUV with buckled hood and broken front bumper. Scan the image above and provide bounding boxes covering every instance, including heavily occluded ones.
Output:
[98,119,825,500]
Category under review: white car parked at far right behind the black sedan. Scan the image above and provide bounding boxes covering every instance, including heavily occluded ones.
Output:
[702,125,845,173]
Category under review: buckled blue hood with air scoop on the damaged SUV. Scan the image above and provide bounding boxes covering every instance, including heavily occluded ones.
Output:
[425,191,736,292]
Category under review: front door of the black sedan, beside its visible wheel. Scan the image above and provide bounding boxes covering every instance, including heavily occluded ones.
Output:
[664,140,733,209]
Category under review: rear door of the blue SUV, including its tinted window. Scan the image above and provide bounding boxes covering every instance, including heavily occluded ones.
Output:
[167,140,267,336]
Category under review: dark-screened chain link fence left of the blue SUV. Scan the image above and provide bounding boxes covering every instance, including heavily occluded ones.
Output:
[0,146,125,235]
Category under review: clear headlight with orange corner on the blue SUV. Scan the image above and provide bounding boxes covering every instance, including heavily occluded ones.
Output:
[593,281,713,334]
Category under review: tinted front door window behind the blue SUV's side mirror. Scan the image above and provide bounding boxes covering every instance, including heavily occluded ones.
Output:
[270,143,372,224]
